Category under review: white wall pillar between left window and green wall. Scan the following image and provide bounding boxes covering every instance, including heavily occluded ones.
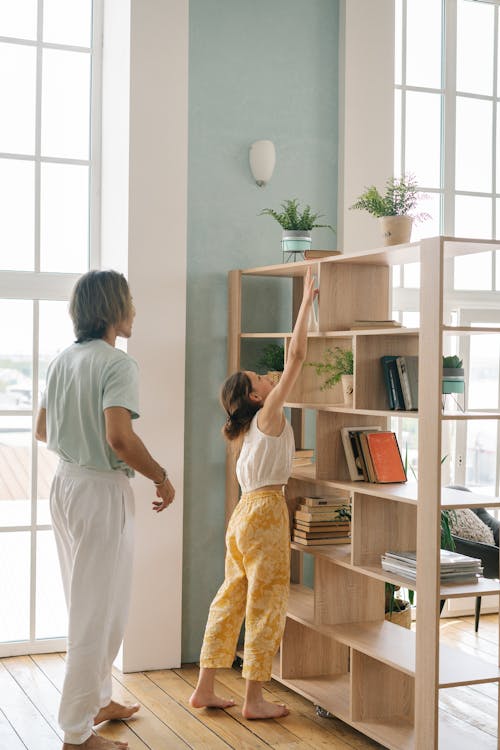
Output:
[102,0,189,671]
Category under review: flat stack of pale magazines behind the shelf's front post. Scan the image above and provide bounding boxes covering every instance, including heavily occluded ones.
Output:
[381,549,483,583]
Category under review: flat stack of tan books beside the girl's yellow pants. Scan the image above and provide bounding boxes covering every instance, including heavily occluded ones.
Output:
[293,496,351,546]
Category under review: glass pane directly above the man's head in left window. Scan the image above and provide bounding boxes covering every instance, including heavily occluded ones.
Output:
[40,164,89,273]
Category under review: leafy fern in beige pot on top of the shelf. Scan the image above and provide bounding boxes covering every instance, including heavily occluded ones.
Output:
[351,174,430,245]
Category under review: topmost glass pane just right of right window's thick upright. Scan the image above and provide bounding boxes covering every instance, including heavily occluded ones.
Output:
[457,0,495,96]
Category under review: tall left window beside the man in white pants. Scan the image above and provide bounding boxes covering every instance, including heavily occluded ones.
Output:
[0,0,102,655]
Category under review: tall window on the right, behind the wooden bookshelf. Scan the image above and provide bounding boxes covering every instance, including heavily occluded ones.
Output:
[393,0,500,495]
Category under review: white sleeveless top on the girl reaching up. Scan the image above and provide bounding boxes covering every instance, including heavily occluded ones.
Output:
[236,412,295,493]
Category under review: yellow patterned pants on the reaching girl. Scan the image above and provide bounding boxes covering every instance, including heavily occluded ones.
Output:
[200,490,290,682]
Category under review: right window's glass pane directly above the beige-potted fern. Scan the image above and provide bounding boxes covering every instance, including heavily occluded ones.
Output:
[405,91,441,188]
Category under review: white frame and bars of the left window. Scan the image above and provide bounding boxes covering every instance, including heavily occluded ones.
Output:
[0,0,104,657]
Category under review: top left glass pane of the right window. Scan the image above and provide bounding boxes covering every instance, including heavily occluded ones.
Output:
[406,0,442,88]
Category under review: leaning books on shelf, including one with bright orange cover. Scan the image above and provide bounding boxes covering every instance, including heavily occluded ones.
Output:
[340,425,406,484]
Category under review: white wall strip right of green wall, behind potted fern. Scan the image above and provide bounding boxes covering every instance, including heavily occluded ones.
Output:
[337,0,394,253]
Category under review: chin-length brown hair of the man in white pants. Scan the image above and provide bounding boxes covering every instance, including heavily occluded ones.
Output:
[69,271,132,344]
